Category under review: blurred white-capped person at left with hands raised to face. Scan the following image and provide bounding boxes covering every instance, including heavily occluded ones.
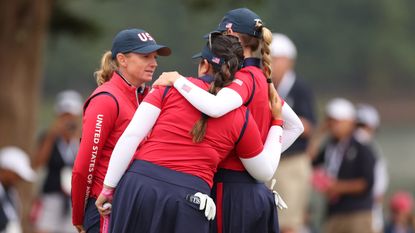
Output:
[33,90,83,233]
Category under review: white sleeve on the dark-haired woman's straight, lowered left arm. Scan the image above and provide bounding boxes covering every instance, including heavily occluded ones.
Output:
[104,102,161,188]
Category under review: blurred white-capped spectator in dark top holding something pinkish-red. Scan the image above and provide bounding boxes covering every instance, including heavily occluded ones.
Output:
[313,98,375,233]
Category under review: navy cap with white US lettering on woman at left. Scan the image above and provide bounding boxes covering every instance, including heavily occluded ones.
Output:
[111,28,171,59]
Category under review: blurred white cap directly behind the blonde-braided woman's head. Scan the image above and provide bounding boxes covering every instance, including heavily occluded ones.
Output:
[270,33,297,60]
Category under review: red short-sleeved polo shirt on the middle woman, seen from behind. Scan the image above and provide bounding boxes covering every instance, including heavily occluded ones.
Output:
[135,78,263,186]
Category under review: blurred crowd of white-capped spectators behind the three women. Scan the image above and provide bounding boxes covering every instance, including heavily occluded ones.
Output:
[0,34,414,233]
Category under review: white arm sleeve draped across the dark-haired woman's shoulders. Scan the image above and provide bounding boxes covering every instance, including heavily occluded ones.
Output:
[174,77,243,118]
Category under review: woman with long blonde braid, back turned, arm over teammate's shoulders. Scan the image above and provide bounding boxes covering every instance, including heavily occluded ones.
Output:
[153,8,304,233]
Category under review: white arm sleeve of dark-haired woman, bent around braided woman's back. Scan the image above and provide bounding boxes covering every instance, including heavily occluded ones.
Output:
[241,125,282,182]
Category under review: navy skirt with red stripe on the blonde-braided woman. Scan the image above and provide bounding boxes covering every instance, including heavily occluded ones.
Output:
[210,169,279,233]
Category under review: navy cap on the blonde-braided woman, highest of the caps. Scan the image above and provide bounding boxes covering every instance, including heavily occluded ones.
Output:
[213,8,262,37]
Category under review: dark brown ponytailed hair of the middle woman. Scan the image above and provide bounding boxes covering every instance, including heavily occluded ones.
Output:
[190,35,244,143]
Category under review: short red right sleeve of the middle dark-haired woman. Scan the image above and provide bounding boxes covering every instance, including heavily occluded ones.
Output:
[235,110,264,159]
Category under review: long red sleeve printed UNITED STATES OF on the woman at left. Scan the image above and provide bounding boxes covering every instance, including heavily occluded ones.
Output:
[71,94,118,225]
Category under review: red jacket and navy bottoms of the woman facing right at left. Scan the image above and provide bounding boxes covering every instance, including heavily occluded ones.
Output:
[72,72,148,232]
